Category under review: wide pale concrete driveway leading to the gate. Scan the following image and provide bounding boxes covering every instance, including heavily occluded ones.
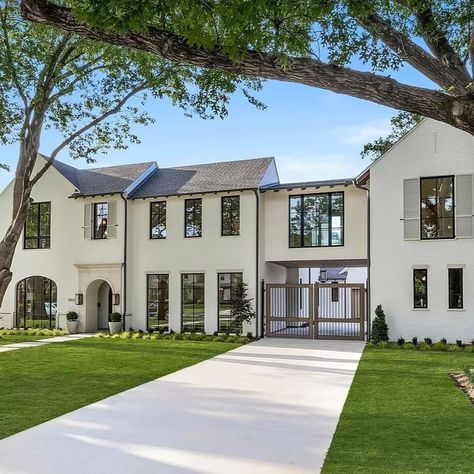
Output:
[0,339,363,474]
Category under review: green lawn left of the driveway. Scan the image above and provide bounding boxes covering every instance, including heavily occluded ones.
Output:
[0,338,239,438]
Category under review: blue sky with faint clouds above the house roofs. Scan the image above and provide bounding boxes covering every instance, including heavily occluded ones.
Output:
[0,62,430,190]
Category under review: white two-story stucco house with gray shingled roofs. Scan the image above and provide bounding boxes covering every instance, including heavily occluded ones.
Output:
[0,120,474,340]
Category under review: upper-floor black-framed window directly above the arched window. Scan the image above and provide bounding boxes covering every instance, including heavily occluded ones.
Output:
[23,202,51,249]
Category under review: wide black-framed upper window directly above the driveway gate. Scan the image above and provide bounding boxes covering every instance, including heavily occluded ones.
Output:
[289,192,344,247]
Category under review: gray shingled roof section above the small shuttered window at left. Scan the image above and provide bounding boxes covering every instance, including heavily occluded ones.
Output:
[53,161,154,196]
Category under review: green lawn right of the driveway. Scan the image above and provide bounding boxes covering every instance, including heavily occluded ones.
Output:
[323,349,474,473]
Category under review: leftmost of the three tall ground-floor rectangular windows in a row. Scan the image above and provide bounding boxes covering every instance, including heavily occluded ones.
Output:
[146,274,169,331]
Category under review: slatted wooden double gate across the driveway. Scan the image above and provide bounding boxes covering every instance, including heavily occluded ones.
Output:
[265,283,366,340]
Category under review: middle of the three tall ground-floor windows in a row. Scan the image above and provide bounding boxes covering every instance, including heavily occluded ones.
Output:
[181,273,205,332]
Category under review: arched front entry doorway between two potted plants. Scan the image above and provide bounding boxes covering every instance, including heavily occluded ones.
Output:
[85,279,113,332]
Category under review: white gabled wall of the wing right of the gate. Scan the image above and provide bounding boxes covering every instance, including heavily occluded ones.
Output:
[370,120,474,341]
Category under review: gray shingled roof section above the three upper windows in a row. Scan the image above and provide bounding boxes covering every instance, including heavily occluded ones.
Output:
[131,158,273,199]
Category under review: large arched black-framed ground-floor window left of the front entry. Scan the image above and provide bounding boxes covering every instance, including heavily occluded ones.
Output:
[16,276,57,328]
